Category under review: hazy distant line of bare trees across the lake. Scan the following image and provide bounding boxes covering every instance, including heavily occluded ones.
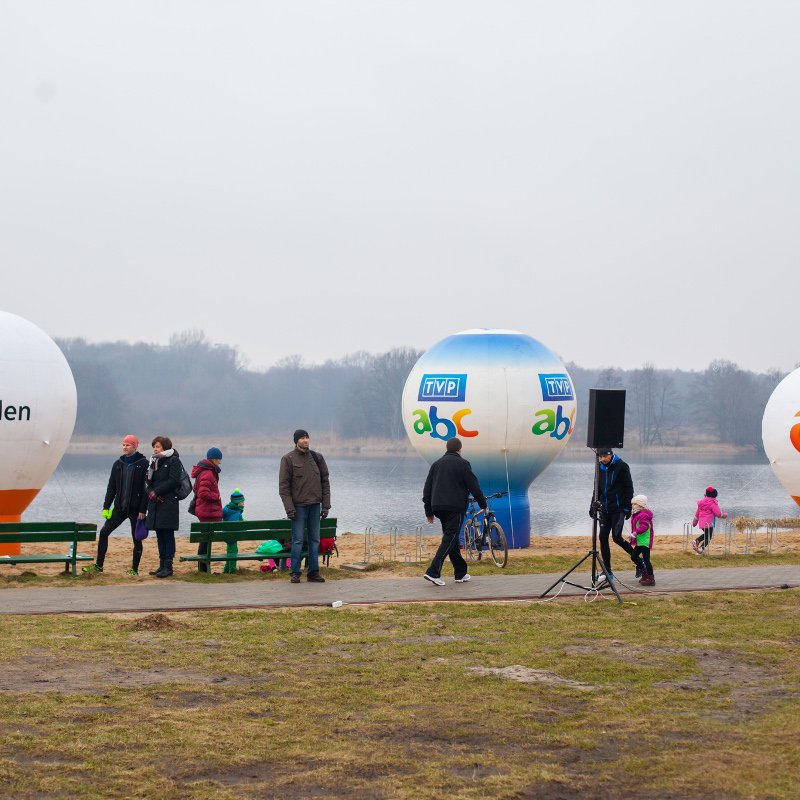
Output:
[58,331,783,449]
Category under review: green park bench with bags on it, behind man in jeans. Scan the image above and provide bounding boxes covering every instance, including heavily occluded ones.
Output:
[181,517,339,571]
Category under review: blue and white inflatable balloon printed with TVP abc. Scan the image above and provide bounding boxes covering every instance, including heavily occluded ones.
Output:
[403,330,576,547]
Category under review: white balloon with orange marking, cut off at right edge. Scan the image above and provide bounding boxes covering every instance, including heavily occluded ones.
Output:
[761,369,800,505]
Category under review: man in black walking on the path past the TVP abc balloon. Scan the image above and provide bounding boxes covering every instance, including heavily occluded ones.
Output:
[422,438,486,586]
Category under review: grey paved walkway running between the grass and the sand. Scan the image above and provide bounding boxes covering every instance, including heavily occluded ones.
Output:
[0,565,800,614]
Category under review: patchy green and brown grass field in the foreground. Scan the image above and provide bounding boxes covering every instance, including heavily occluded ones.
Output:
[0,588,800,800]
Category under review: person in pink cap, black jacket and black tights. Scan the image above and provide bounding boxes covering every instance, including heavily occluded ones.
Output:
[83,434,147,577]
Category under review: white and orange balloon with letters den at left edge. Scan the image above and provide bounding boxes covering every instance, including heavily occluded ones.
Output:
[0,311,78,555]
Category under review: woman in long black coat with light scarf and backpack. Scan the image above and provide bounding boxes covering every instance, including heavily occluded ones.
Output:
[145,436,183,578]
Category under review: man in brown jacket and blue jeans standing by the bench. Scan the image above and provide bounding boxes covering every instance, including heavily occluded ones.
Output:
[278,429,331,583]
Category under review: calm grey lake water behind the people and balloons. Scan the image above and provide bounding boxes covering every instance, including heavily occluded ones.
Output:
[23,454,798,539]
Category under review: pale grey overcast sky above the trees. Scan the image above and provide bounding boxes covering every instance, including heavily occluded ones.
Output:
[0,0,800,370]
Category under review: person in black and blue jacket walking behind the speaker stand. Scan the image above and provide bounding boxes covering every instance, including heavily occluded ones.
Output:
[589,448,639,577]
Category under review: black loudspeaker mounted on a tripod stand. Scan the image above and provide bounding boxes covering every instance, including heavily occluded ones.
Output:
[540,389,625,603]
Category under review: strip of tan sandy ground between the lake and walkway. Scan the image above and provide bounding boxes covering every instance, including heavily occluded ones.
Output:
[6,530,800,580]
